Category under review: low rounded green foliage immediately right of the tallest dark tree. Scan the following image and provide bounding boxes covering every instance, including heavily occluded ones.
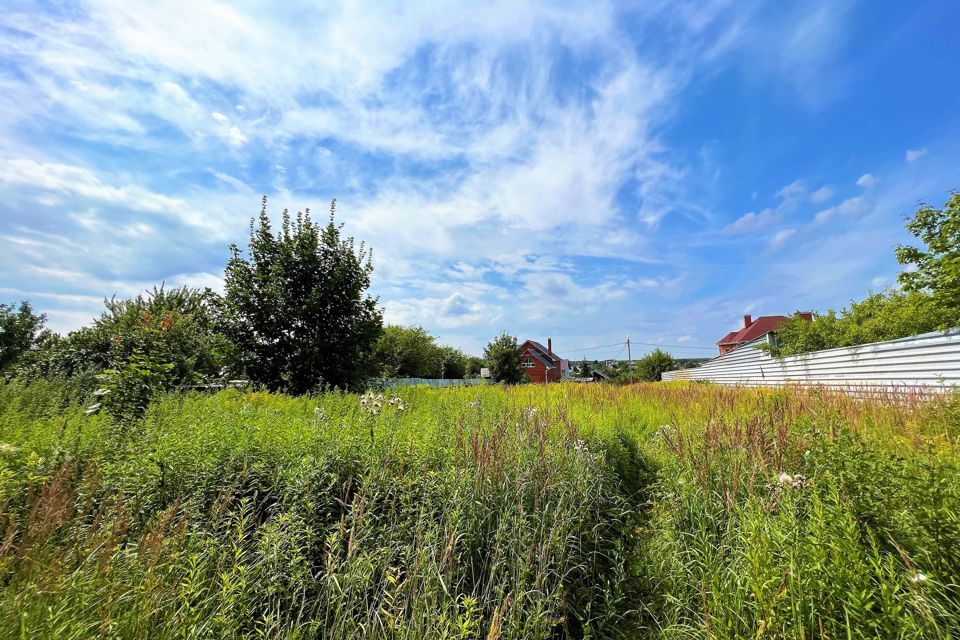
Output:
[373,325,468,378]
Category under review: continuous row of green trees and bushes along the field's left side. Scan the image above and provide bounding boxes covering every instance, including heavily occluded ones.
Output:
[0,198,482,417]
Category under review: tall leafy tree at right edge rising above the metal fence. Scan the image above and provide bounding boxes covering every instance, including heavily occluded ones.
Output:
[896,192,960,329]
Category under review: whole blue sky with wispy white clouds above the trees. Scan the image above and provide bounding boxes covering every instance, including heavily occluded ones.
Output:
[0,0,960,358]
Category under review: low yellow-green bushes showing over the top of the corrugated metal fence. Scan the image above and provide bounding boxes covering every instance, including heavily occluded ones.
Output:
[762,289,945,356]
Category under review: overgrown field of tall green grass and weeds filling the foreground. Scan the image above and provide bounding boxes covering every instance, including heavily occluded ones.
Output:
[0,384,960,638]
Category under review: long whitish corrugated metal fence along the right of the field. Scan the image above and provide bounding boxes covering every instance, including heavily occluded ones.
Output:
[663,329,960,393]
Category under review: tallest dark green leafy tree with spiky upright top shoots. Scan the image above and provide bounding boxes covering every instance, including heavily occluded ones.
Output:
[223,198,382,393]
